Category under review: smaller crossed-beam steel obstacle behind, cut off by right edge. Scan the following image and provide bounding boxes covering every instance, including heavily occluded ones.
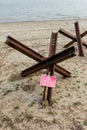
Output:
[58,21,87,56]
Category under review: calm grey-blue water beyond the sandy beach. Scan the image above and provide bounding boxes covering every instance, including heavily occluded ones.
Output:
[0,0,87,22]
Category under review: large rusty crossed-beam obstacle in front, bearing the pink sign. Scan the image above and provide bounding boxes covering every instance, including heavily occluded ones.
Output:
[5,32,75,105]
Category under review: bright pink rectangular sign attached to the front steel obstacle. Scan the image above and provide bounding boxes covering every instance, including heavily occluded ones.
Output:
[40,75,56,88]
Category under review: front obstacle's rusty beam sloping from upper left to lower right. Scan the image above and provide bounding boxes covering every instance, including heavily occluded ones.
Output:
[5,36,71,77]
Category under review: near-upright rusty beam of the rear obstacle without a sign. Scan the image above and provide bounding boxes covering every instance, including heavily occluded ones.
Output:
[75,22,84,56]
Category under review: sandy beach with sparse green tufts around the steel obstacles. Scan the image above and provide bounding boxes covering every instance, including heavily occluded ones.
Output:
[0,20,87,130]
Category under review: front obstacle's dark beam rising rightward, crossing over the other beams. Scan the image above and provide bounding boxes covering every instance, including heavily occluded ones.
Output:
[21,47,75,77]
